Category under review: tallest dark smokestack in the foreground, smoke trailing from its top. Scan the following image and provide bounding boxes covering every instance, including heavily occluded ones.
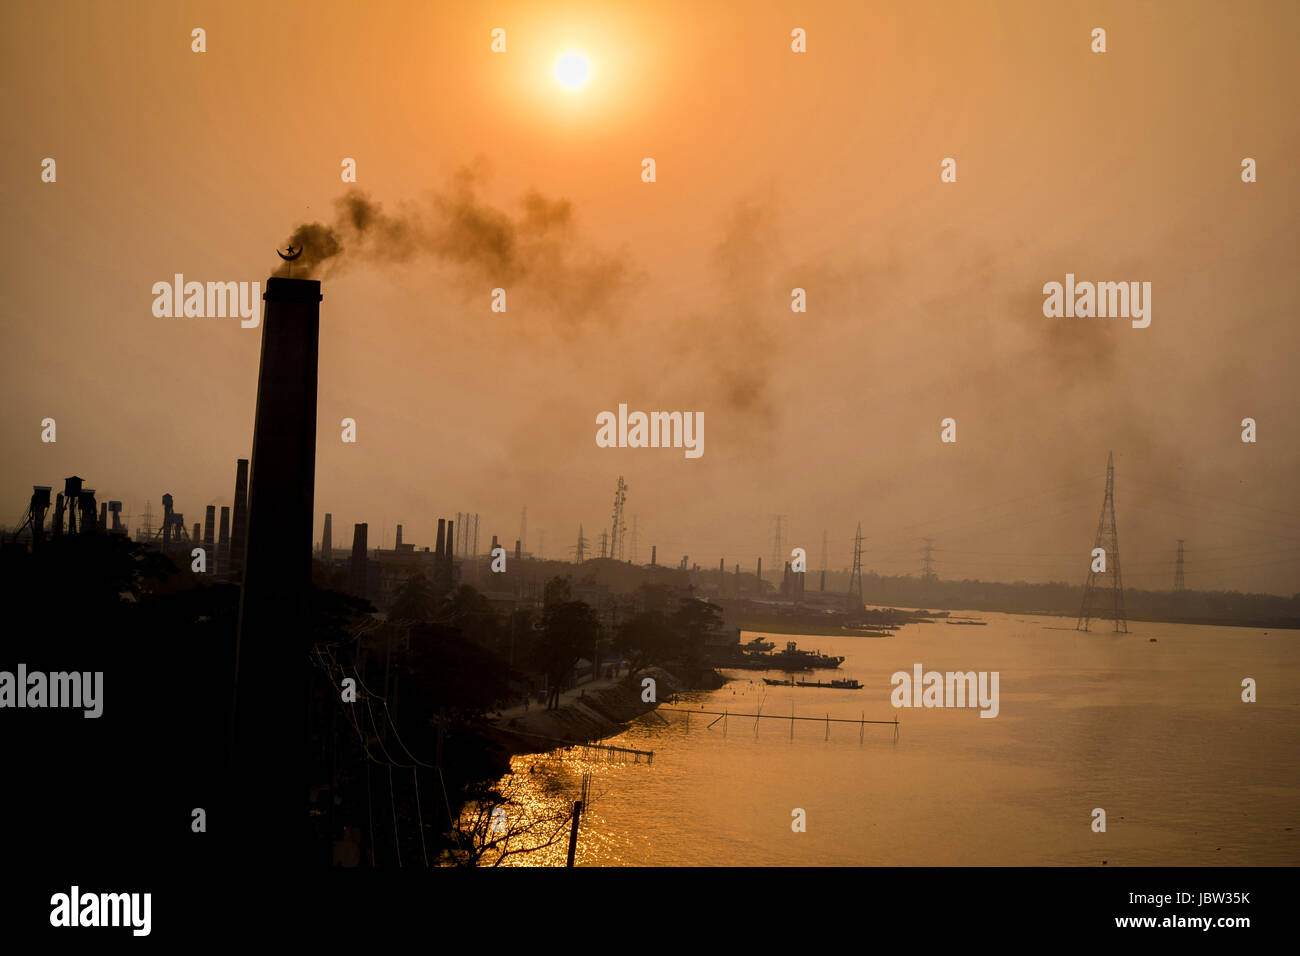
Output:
[228,277,321,871]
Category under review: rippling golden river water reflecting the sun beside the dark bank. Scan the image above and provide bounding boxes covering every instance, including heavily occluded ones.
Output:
[501,613,1300,866]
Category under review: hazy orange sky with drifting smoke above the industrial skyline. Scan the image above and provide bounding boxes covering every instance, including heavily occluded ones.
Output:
[0,1,1300,594]
